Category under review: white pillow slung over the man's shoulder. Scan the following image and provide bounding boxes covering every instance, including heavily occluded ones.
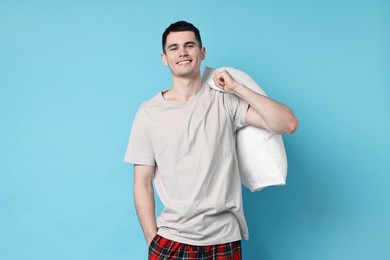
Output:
[202,67,287,191]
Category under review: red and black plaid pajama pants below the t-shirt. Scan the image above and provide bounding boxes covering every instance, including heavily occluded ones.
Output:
[148,235,241,260]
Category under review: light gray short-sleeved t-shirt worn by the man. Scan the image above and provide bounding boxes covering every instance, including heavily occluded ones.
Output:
[124,84,248,245]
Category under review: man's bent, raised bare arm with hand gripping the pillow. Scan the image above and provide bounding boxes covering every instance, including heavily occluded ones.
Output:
[214,70,298,134]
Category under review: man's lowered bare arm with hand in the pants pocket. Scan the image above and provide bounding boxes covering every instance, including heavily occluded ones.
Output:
[133,164,157,246]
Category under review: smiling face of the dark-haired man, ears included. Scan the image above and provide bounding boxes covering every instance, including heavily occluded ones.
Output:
[161,31,206,78]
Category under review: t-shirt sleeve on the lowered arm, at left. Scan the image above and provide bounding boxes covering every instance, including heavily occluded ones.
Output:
[124,110,156,166]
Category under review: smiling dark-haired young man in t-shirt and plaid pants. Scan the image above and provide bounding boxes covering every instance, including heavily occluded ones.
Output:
[125,21,298,259]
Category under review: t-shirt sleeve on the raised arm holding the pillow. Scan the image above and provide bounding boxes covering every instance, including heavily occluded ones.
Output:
[224,93,249,131]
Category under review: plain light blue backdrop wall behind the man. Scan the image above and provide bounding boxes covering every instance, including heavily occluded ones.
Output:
[0,0,390,260]
